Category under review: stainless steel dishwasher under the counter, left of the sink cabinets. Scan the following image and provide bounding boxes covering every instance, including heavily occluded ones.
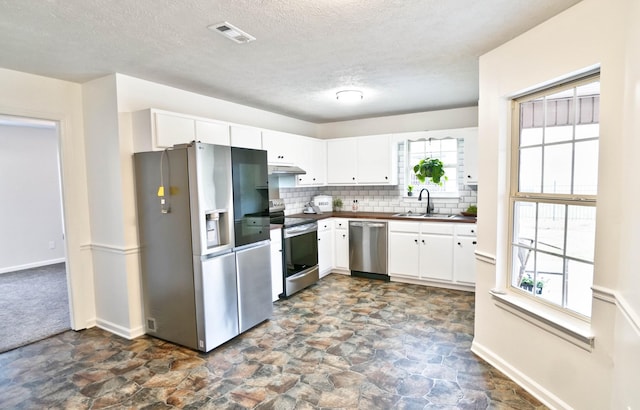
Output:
[349,221,389,281]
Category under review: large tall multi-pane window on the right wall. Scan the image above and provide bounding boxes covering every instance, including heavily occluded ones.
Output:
[509,75,600,319]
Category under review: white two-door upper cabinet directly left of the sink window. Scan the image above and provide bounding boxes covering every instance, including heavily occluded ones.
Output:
[327,135,398,185]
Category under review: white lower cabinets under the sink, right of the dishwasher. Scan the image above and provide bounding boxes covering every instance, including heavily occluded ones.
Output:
[388,221,475,287]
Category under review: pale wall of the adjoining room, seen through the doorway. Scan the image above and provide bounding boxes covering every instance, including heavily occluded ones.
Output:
[0,125,64,273]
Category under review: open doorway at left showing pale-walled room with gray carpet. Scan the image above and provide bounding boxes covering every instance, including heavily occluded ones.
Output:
[0,115,71,352]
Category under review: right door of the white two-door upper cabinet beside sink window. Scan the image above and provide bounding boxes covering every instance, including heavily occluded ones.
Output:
[356,135,397,184]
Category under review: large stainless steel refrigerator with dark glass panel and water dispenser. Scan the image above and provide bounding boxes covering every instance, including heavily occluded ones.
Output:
[134,142,273,352]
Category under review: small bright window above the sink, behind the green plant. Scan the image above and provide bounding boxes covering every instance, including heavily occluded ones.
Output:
[405,137,461,198]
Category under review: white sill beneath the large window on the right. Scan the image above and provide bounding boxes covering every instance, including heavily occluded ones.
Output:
[489,290,595,352]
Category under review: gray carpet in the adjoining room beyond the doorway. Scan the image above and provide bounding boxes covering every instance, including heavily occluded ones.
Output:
[0,263,71,353]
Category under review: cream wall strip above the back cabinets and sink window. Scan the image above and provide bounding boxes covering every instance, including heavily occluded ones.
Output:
[316,107,478,139]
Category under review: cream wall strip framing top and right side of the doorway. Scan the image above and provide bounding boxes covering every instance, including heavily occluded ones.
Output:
[0,69,95,329]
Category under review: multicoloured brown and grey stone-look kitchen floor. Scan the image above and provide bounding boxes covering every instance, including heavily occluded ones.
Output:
[0,274,545,409]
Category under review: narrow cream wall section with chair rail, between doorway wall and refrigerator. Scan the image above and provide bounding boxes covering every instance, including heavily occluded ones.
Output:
[82,75,144,339]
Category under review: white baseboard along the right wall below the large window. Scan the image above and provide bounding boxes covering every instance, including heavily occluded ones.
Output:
[471,340,572,409]
